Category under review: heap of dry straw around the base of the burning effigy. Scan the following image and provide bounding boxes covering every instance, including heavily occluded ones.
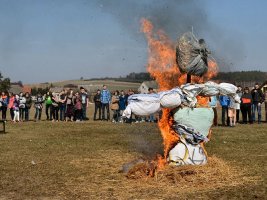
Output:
[126,156,257,190]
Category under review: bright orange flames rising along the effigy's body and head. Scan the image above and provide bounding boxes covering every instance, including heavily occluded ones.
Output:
[141,18,217,169]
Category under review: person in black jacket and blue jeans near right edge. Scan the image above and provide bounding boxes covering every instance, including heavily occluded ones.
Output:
[251,83,264,123]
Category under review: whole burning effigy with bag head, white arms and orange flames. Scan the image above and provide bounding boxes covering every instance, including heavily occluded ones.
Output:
[123,19,239,173]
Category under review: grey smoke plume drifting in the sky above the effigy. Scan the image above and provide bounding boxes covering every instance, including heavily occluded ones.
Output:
[94,0,244,71]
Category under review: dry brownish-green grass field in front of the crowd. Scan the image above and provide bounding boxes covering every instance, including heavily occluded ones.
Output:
[0,105,267,199]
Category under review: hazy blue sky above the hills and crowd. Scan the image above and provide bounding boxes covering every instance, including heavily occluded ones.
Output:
[0,0,267,83]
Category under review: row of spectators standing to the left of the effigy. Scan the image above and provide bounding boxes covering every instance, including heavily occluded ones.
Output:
[0,85,144,122]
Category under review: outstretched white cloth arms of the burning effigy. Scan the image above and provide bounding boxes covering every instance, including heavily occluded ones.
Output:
[123,81,240,118]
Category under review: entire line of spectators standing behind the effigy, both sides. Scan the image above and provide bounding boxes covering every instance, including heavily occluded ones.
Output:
[0,83,267,124]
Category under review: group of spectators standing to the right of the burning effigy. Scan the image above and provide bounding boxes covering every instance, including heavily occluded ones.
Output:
[214,83,267,127]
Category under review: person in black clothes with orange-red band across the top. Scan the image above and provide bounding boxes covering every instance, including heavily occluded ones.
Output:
[240,87,253,124]
